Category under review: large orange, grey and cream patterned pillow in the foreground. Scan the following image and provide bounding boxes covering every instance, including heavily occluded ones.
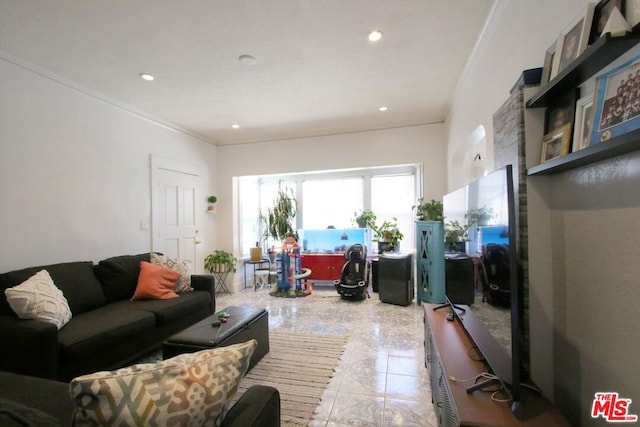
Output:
[69,340,258,426]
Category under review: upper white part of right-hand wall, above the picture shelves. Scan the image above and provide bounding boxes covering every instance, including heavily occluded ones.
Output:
[445,0,587,190]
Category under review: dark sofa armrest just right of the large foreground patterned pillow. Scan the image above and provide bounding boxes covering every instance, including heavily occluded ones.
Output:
[222,385,280,427]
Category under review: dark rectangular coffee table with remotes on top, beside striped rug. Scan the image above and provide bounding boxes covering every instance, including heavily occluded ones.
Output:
[162,306,269,370]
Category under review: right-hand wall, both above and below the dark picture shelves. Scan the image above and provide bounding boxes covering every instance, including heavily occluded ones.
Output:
[446,0,640,425]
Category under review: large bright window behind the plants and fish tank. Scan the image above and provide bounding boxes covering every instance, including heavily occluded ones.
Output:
[238,164,422,255]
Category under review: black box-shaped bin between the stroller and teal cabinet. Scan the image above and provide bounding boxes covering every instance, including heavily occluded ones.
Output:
[378,253,414,305]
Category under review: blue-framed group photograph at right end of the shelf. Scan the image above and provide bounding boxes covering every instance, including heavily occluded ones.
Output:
[589,51,640,145]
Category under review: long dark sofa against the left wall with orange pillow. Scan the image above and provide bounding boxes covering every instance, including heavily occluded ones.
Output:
[0,253,215,382]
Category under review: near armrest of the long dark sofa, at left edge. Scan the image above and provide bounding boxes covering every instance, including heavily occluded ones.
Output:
[0,315,58,379]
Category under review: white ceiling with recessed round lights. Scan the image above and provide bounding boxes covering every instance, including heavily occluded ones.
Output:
[0,0,494,145]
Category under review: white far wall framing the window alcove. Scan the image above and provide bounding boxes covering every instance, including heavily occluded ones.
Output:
[216,124,446,288]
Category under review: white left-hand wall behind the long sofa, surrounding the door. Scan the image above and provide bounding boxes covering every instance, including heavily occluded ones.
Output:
[0,59,216,272]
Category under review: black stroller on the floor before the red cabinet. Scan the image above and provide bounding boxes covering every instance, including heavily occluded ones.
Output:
[333,243,369,300]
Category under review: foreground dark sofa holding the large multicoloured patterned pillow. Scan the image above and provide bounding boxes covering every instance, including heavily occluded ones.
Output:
[0,372,280,427]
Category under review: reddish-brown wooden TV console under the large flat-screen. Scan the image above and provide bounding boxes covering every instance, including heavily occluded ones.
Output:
[423,303,569,427]
